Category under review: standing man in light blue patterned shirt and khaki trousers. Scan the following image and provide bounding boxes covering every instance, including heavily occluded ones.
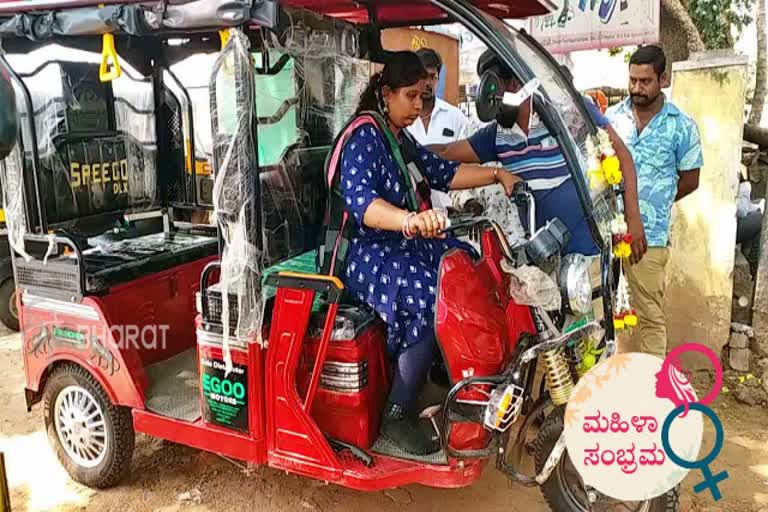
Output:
[606,46,704,358]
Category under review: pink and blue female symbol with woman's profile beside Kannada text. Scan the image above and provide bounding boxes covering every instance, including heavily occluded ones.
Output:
[656,343,728,501]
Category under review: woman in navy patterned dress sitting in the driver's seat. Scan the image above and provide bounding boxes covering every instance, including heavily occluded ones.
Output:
[341,52,519,455]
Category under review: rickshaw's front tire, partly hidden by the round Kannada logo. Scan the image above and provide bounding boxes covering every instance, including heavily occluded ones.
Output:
[533,407,680,512]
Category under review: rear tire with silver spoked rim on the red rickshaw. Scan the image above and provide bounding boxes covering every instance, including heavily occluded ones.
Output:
[43,364,135,489]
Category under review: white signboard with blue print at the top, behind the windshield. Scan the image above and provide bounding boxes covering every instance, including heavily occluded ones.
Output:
[529,0,660,53]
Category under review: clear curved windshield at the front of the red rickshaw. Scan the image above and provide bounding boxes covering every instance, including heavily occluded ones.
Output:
[482,13,615,246]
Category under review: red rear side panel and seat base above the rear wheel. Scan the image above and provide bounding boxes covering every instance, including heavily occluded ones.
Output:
[19,258,213,409]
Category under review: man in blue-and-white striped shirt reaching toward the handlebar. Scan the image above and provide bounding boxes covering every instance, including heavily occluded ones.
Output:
[430,50,645,261]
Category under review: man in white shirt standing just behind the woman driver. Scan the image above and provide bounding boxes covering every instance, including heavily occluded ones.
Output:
[407,48,469,208]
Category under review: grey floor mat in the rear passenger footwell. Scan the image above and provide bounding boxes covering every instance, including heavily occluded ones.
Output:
[144,348,200,423]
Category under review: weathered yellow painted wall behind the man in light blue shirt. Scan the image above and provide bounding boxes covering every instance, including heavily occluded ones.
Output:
[666,57,747,368]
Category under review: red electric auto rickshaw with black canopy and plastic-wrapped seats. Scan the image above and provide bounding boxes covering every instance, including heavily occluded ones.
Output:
[0,0,677,512]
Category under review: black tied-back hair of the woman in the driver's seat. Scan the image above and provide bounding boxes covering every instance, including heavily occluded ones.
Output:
[355,52,428,114]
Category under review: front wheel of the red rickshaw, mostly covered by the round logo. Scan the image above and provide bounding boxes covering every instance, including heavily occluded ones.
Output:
[533,407,680,512]
